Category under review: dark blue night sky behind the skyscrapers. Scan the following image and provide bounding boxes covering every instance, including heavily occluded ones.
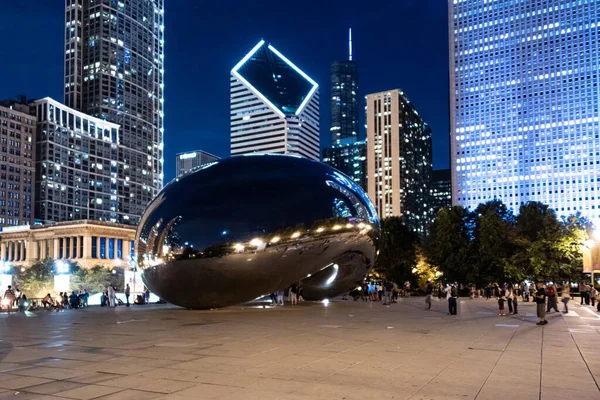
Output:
[0,0,449,181]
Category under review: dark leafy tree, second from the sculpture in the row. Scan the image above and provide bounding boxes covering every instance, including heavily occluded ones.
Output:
[425,206,478,282]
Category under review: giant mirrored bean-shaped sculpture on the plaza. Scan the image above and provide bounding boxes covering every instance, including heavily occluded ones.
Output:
[136,155,380,309]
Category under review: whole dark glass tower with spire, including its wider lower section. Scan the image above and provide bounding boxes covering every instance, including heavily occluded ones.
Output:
[323,29,367,189]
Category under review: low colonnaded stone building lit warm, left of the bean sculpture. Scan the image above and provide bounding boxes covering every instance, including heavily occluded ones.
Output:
[0,220,136,268]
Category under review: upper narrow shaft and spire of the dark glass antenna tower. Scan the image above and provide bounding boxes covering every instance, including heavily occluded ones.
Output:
[329,30,358,146]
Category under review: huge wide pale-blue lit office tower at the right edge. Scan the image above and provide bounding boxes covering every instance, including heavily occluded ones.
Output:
[449,0,600,221]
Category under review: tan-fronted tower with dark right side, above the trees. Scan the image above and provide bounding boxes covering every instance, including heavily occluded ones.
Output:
[367,89,432,237]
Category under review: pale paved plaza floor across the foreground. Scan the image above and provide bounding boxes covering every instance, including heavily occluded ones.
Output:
[0,297,600,400]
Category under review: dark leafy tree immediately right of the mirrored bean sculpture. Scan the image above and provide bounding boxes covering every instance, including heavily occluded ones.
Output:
[375,217,418,284]
